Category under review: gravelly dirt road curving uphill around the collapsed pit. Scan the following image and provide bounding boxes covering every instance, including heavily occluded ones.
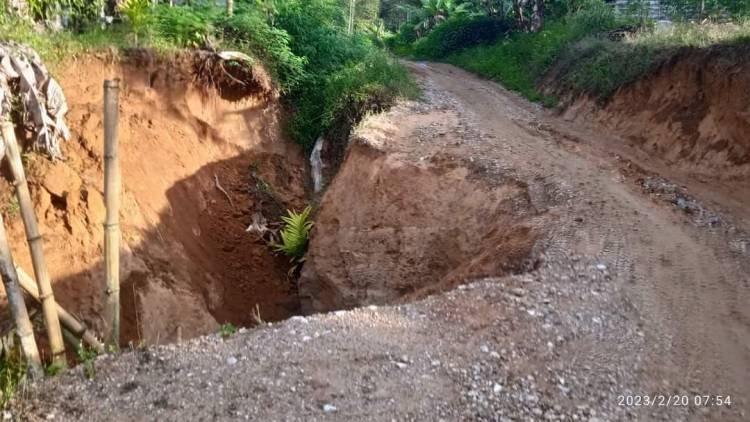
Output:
[25,64,750,421]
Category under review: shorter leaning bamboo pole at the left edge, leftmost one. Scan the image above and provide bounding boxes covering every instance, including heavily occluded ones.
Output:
[0,215,44,379]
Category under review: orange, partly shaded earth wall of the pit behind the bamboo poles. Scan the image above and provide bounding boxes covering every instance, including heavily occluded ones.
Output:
[0,52,305,343]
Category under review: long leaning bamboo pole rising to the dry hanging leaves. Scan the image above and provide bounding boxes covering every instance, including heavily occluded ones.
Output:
[1,122,67,367]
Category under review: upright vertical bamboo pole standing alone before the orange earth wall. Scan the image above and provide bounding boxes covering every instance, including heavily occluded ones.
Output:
[104,79,120,346]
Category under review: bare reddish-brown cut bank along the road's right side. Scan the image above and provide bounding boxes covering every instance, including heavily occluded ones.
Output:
[565,44,750,177]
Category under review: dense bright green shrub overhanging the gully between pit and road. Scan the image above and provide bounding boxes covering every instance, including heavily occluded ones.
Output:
[275,0,416,151]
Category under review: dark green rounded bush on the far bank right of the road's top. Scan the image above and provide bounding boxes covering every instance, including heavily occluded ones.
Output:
[412,16,512,59]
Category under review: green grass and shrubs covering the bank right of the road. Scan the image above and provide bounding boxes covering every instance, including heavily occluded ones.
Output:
[387,0,750,106]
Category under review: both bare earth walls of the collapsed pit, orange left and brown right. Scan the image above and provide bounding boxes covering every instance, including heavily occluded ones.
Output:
[2,54,539,350]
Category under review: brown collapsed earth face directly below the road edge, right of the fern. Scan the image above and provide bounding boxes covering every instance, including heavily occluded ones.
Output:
[299,134,537,312]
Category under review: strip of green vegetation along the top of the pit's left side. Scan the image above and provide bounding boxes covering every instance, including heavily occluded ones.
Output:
[0,0,418,150]
